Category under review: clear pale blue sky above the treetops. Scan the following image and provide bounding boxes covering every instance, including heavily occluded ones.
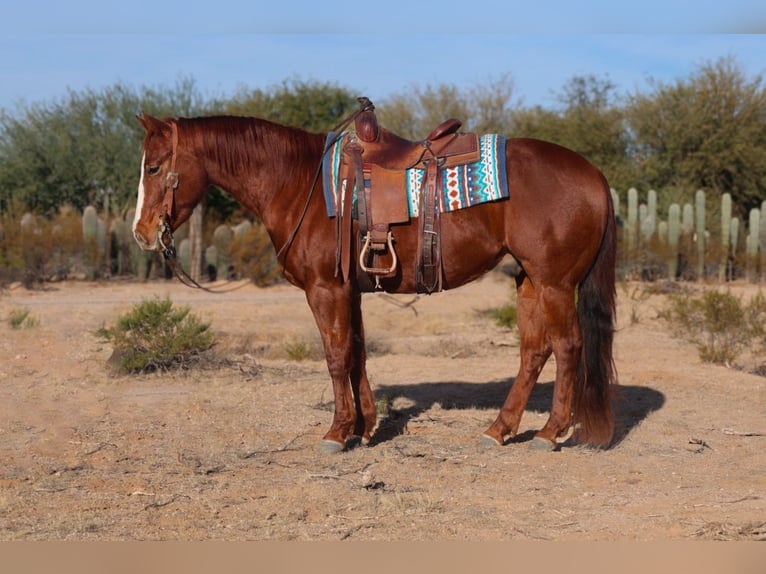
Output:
[0,0,766,112]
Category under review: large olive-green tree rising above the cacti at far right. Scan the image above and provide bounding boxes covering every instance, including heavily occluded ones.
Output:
[626,58,766,216]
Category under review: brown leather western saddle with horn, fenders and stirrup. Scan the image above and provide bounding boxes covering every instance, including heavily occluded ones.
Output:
[337,98,480,294]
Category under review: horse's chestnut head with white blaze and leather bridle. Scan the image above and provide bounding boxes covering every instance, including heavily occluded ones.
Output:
[133,113,207,251]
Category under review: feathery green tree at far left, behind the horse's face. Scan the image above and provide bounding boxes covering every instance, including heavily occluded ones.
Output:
[0,79,216,215]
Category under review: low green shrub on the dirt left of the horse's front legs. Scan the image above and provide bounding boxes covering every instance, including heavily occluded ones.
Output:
[98,297,215,373]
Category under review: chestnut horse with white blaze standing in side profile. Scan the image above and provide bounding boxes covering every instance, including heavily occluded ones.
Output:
[133,108,616,452]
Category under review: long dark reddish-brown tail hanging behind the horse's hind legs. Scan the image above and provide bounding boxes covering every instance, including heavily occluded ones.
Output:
[574,179,617,447]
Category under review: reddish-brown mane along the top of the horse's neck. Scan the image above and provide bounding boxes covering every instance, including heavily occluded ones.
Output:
[177,116,324,173]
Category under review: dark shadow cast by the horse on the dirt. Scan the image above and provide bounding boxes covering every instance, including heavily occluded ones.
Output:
[371,378,665,447]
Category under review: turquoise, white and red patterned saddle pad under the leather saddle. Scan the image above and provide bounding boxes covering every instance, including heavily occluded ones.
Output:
[322,132,508,217]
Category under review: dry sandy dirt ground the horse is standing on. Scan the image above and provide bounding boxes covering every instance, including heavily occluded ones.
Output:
[0,272,766,541]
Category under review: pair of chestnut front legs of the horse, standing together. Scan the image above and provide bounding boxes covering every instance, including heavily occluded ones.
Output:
[306,284,376,453]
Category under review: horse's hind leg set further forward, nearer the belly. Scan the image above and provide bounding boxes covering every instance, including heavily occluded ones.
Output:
[482,274,552,444]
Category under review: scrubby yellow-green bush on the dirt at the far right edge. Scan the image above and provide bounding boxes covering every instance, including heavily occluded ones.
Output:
[665,291,766,365]
